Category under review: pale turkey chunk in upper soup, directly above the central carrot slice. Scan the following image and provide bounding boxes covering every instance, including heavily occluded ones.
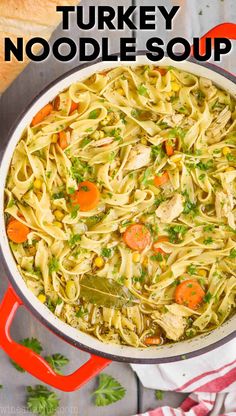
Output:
[125,144,151,170]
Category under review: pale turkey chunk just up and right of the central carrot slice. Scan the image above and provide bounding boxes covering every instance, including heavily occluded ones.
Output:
[156,194,184,223]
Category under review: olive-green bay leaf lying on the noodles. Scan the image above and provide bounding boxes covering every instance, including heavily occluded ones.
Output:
[80,276,133,309]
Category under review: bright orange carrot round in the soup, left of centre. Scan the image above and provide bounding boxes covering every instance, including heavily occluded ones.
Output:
[71,181,100,211]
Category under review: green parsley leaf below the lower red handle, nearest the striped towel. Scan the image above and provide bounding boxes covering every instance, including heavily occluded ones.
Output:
[93,374,126,406]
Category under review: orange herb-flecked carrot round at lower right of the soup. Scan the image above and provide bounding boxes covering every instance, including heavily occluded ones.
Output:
[174,279,205,309]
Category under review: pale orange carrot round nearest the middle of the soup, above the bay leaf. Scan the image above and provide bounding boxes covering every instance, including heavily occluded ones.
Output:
[123,224,151,251]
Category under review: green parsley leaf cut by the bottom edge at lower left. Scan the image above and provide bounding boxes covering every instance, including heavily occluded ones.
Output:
[26,385,59,416]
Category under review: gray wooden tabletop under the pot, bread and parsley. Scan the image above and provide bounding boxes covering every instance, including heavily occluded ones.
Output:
[0,0,233,416]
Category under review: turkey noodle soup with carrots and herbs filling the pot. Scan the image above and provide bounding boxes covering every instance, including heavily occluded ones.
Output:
[5,65,236,347]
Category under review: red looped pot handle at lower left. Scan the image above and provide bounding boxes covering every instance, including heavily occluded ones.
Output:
[0,287,111,392]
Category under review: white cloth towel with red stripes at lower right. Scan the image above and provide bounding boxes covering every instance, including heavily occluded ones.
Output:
[132,340,236,416]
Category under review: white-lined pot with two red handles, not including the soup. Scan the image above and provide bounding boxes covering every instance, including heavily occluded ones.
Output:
[0,23,236,391]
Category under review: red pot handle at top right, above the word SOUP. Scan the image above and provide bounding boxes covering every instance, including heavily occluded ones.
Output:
[191,23,236,55]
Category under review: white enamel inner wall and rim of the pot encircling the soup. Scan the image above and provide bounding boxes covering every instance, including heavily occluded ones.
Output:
[0,55,236,363]
